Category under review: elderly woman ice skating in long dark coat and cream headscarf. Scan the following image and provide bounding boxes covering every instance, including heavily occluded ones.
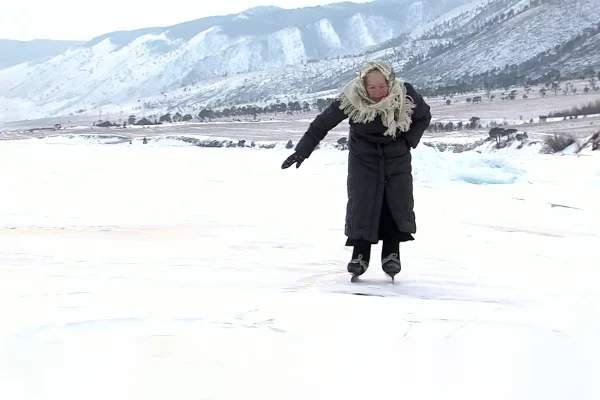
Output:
[281,61,431,280]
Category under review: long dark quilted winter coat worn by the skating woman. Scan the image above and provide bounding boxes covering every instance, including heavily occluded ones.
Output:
[295,83,431,243]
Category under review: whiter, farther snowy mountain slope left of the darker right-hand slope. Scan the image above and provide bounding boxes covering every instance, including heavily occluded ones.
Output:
[0,0,469,122]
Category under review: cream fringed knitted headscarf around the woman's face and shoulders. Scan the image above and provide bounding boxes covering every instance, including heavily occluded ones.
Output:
[338,61,415,136]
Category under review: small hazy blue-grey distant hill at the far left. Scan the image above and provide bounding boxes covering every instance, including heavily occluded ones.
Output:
[0,39,84,70]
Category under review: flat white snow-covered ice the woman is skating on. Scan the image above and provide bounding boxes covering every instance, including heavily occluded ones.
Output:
[0,139,600,400]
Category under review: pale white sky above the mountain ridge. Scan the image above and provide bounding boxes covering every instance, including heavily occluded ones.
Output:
[0,0,371,40]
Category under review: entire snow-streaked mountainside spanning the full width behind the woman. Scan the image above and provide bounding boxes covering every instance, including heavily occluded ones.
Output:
[0,0,600,121]
